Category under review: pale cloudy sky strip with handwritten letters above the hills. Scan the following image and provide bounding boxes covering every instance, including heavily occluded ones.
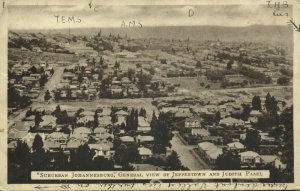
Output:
[8,4,291,29]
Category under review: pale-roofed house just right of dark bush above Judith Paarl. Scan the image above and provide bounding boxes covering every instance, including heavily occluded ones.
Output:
[239,151,262,167]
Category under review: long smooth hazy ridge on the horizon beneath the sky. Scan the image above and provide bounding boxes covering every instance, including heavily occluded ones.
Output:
[12,25,293,45]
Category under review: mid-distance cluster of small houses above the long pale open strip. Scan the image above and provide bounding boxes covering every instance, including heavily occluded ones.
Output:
[55,55,176,100]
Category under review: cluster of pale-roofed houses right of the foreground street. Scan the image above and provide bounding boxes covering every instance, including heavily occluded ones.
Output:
[159,92,286,169]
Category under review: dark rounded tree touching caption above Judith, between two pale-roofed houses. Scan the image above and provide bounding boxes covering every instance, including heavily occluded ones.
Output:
[215,150,241,170]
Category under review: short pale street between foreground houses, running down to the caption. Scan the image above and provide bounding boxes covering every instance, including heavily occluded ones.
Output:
[171,133,208,170]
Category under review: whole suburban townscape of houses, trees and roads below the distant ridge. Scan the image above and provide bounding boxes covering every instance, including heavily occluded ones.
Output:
[7,26,294,183]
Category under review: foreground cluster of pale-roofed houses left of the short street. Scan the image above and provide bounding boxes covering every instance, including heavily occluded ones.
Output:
[8,108,154,161]
